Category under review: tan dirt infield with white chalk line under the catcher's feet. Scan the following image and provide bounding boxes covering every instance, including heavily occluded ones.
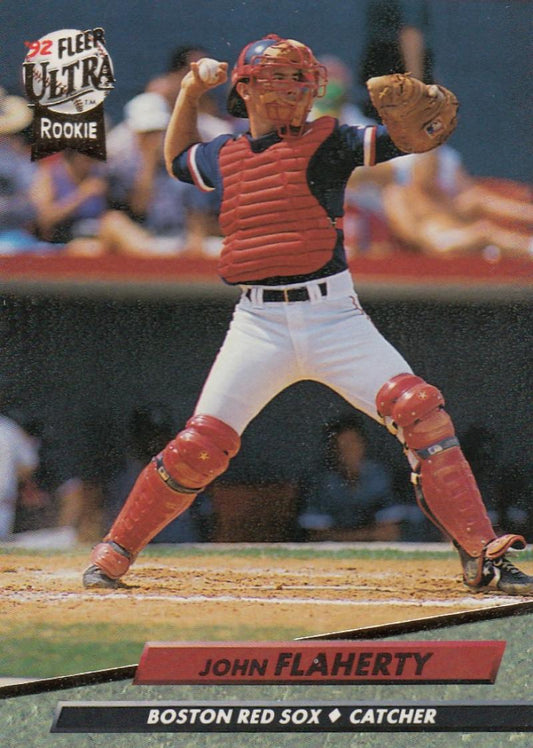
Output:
[0,545,533,640]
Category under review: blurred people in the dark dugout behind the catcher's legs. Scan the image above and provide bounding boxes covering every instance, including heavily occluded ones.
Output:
[0,403,533,547]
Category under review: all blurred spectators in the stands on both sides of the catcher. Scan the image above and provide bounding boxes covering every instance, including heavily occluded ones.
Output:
[0,39,533,261]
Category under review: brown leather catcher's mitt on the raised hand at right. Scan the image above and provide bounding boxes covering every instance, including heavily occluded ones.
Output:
[366,73,459,153]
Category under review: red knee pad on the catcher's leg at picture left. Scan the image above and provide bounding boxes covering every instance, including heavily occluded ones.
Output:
[155,415,241,493]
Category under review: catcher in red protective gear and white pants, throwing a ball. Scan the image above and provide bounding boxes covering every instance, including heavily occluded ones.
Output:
[83,35,533,595]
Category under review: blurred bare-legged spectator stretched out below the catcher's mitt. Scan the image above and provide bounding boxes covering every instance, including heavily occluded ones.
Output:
[383,146,533,261]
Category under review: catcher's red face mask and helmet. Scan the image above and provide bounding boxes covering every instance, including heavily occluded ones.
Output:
[227,34,327,133]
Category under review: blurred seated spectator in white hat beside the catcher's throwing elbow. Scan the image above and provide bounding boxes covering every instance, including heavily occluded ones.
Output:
[105,93,220,256]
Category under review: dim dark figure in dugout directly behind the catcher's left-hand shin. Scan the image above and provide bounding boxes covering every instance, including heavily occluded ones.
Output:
[103,403,211,543]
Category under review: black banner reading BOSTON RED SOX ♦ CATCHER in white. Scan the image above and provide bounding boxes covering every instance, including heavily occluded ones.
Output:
[51,701,533,733]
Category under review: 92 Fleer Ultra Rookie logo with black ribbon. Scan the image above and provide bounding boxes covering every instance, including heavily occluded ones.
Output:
[22,28,115,160]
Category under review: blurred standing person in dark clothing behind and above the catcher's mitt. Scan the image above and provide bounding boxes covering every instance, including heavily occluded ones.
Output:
[359,0,433,119]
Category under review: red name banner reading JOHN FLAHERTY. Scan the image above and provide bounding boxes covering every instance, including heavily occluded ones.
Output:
[133,641,505,685]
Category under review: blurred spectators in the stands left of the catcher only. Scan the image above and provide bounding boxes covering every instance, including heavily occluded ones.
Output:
[0,46,233,257]
